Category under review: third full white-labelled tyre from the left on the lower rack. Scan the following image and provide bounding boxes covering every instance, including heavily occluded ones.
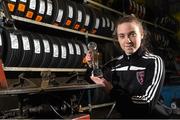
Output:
[30,33,44,67]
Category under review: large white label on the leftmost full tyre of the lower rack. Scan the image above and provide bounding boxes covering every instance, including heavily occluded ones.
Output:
[10,33,19,49]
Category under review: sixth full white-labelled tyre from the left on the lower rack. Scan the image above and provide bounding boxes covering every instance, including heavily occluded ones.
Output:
[57,38,69,68]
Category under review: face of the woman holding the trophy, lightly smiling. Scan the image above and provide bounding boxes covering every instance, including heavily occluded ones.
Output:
[117,22,143,55]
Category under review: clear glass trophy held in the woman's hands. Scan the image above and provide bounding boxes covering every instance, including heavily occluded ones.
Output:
[88,42,103,77]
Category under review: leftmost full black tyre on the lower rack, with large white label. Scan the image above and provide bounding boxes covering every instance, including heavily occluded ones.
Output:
[3,30,22,67]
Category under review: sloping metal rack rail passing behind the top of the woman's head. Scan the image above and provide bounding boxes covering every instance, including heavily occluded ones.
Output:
[85,0,175,34]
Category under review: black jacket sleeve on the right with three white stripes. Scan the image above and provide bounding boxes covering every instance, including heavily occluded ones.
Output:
[131,56,165,107]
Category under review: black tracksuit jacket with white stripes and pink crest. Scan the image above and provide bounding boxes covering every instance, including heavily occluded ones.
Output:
[103,48,165,118]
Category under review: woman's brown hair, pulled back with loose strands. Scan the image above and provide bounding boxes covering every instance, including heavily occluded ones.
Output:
[114,15,149,51]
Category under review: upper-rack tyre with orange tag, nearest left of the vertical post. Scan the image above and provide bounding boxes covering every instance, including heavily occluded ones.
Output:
[73,3,86,30]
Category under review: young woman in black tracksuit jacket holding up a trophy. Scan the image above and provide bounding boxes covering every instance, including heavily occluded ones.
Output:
[86,15,165,118]
